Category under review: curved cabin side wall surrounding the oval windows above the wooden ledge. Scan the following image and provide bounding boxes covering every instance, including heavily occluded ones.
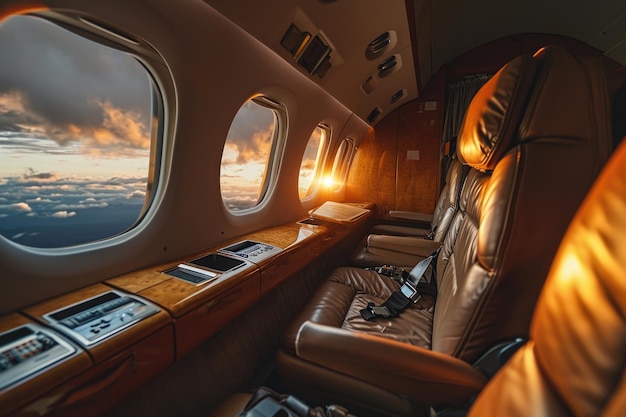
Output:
[0,0,368,314]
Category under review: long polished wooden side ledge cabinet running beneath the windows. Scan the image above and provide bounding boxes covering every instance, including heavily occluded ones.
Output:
[0,213,370,417]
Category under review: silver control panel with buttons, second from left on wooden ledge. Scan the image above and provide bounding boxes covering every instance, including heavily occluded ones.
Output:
[43,290,160,347]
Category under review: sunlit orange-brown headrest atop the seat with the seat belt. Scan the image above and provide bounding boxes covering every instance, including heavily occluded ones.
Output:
[457,55,539,171]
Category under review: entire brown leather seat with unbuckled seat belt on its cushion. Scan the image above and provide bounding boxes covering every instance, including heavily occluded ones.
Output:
[276,47,612,415]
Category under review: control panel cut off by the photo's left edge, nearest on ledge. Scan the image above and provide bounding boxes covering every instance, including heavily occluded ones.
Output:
[0,323,77,389]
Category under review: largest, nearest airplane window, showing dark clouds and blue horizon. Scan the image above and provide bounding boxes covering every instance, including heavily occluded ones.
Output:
[0,16,162,248]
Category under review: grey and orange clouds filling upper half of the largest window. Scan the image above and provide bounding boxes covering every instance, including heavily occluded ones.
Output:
[0,16,152,158]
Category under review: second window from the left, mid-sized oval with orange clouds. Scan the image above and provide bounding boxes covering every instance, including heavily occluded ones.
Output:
[220,96,286,212]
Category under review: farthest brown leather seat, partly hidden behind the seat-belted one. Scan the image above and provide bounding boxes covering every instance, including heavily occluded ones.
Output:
[351,158,468,267]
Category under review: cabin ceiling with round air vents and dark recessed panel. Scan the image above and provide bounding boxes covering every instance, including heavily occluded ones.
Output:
[205,0,626,120]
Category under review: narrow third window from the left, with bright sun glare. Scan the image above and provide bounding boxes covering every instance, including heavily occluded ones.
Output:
[298,124,330,200]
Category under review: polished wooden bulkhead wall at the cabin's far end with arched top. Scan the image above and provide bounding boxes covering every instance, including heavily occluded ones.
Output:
[346,33,621,220]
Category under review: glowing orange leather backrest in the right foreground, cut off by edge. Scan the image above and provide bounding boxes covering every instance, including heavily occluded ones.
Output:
[469,137,626,417]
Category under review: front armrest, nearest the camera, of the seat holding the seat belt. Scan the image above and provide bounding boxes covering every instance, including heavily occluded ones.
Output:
[296,321,487,405]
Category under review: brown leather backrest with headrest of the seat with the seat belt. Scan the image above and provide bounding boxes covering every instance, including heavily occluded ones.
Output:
[432,47,612,362]
